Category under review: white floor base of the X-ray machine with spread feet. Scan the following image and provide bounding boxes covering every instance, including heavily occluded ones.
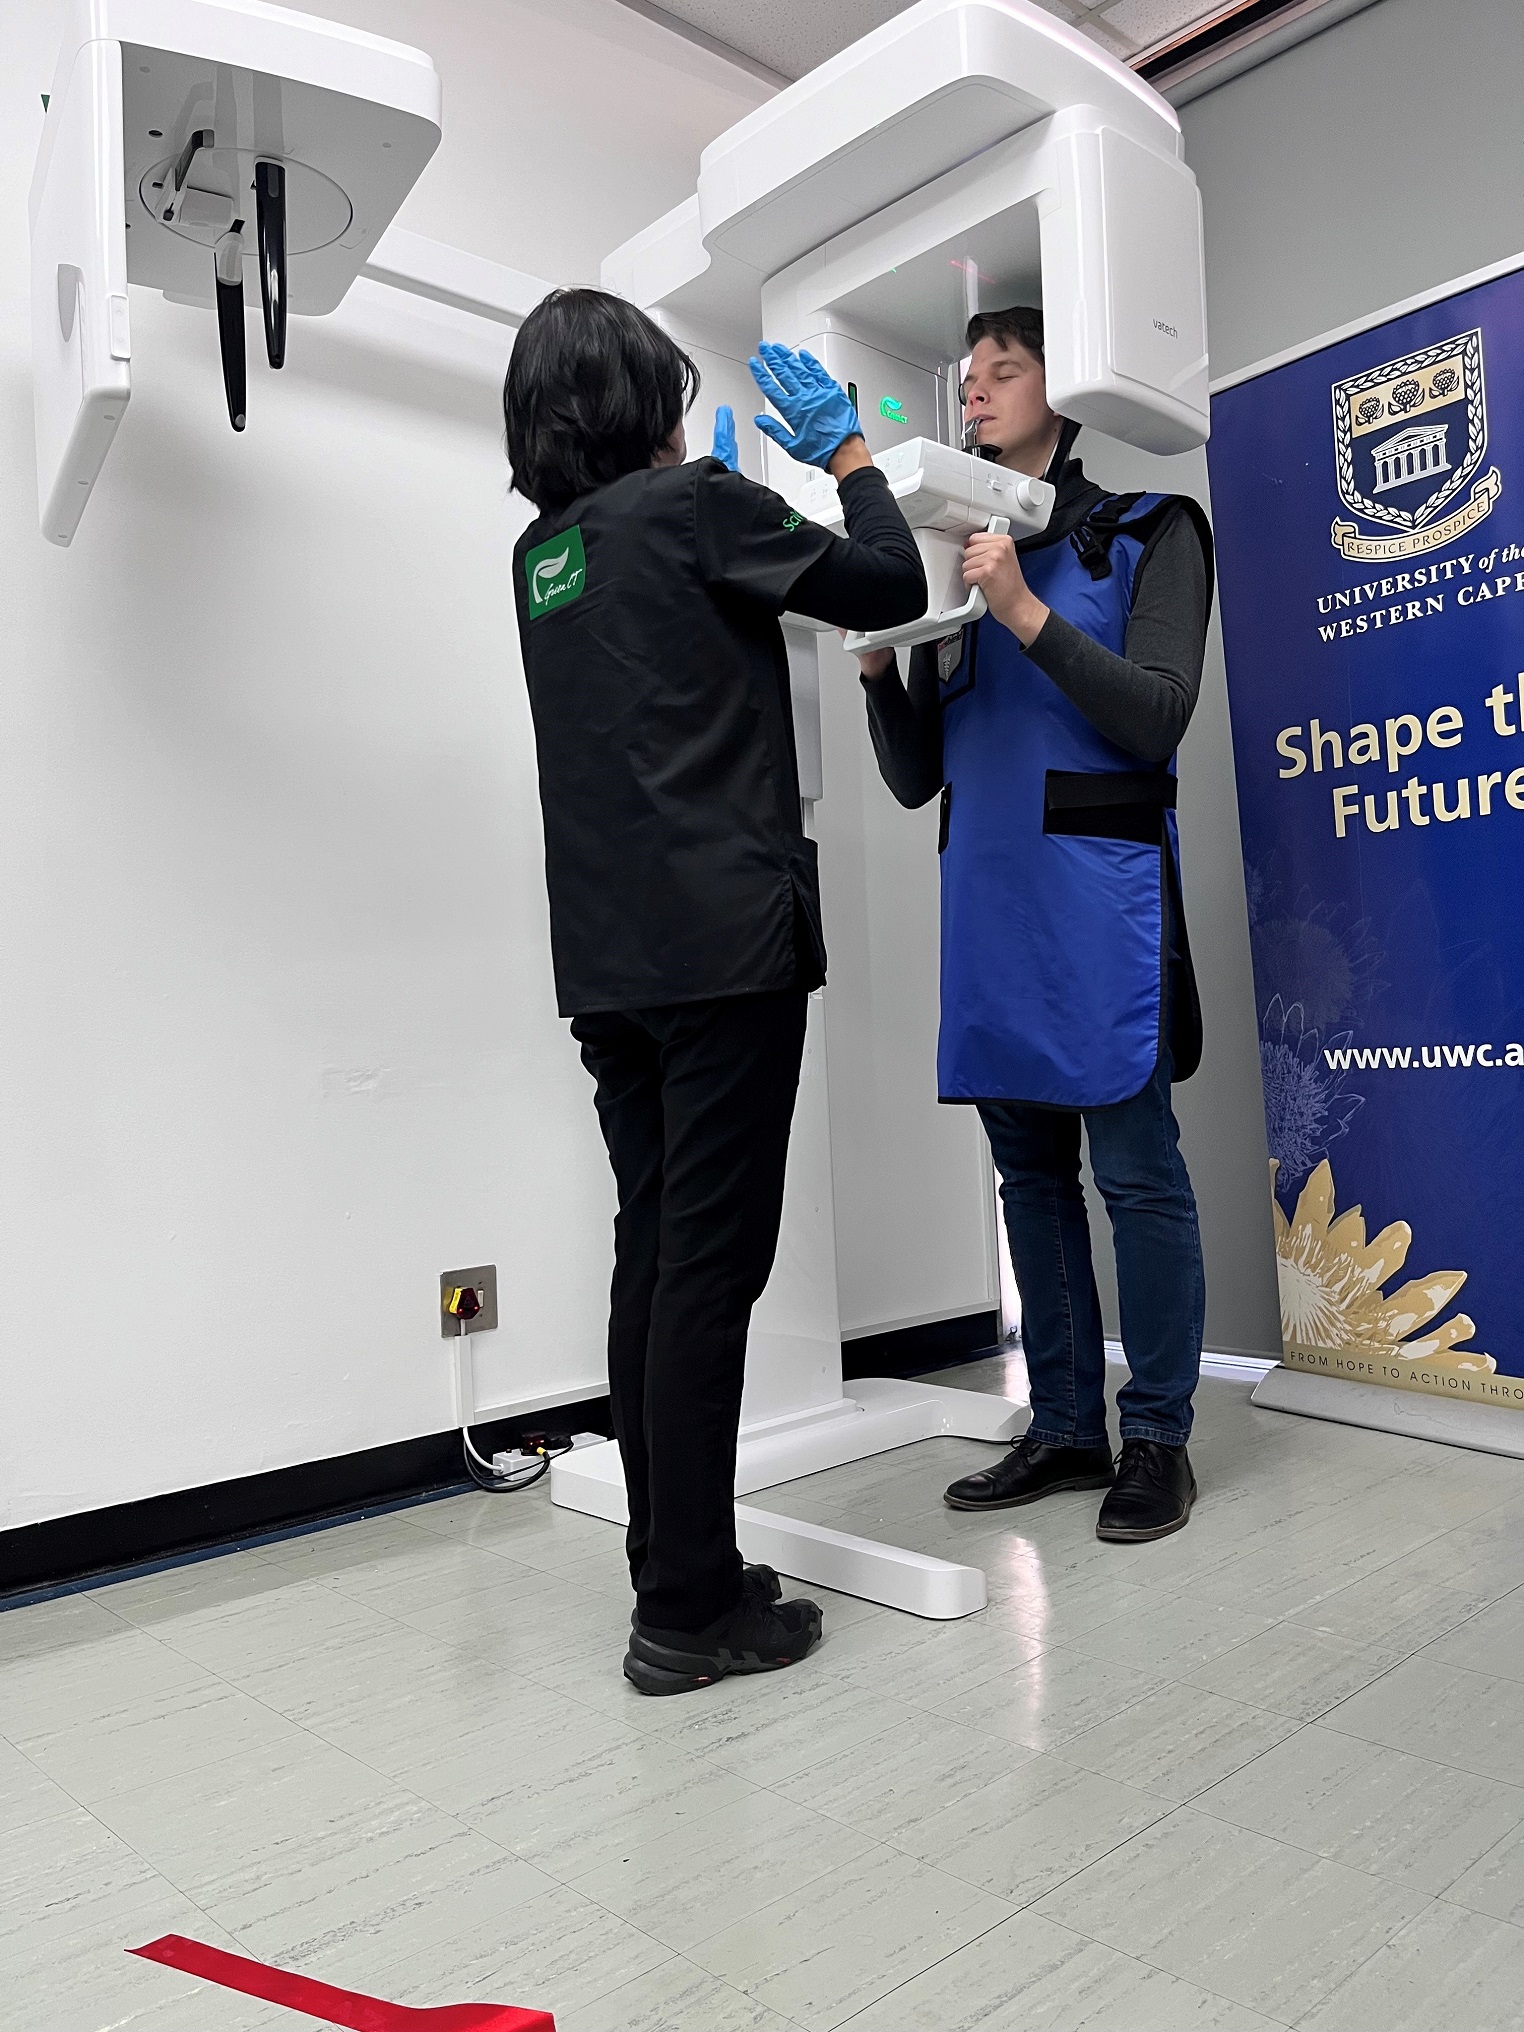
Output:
[551,1376,1026,1622]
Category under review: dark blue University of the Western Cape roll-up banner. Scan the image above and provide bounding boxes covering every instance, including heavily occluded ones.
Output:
[1209,254,1524,1453]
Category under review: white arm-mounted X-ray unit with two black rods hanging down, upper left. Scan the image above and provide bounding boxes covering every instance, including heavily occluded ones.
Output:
[30,0,439,545]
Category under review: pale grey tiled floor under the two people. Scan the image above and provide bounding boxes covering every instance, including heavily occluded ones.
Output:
[0,1366,1524,2032]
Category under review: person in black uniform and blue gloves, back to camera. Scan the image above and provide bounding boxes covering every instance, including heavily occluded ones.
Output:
[504,289,927,1695]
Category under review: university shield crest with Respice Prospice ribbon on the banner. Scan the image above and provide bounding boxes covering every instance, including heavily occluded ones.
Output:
[1331,331,1504,561]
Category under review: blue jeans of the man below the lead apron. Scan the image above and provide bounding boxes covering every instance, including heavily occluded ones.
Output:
[979,1051,1207,1447]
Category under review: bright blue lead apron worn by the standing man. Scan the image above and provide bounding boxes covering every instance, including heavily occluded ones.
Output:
[937,494,1195,1107]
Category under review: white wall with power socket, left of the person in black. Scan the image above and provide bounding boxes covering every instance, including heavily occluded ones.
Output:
[0,0,764,1528]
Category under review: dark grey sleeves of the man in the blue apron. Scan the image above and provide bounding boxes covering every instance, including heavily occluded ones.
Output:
[862,495,1209,807]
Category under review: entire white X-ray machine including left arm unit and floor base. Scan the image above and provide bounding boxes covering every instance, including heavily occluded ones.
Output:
[30,0,1207,1617]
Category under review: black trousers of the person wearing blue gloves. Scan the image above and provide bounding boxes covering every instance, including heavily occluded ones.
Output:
[571,988,807,1630]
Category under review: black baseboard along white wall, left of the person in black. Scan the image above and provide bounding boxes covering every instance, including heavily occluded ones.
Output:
[0,1398,614,1609]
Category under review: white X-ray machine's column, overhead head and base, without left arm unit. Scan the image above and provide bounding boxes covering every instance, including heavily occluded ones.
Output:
[551,0,1207,1617]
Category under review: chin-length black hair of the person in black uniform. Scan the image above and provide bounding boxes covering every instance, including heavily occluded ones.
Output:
[502,289,699,514]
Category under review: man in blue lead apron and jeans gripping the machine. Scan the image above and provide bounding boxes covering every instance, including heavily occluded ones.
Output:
[862,307,1211,1544]
